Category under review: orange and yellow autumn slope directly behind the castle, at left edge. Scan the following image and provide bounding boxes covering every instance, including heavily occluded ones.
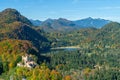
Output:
[0,39,37,74]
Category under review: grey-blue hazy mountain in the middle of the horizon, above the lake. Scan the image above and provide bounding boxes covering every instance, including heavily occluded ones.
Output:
[40,18,77,31]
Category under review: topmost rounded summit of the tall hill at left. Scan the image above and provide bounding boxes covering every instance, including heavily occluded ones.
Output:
[0,8,32,25]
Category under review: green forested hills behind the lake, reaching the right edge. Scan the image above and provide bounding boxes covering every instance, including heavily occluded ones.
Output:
[46,22,120,47]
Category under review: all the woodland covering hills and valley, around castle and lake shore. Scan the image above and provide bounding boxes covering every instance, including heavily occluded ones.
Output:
[0,9,120,80]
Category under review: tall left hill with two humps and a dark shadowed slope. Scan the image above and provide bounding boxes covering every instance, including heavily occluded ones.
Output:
[0,9,50,51]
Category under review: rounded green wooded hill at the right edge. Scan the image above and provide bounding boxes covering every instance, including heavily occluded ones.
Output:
[95,22,120,47]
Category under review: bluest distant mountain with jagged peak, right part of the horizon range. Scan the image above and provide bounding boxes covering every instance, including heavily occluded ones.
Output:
[74,17,110,28]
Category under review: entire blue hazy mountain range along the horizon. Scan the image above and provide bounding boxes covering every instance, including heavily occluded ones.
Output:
[31,17,111,32]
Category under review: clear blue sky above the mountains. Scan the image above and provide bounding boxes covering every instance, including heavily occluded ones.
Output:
[0,0,120,22]
